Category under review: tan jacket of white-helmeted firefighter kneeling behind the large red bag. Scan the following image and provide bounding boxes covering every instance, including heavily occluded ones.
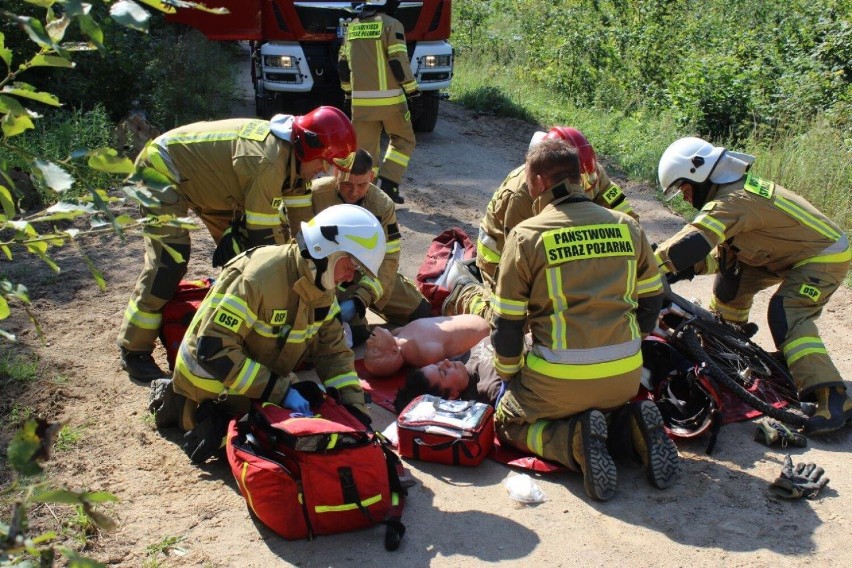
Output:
[174,243,364,404]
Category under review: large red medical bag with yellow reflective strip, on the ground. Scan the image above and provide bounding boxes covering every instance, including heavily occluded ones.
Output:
[226,395,405,550]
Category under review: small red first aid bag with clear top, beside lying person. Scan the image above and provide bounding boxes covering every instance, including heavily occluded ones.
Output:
[396,394,494,466]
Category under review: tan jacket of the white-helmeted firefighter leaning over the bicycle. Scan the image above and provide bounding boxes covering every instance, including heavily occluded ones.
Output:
[657,174,852,274]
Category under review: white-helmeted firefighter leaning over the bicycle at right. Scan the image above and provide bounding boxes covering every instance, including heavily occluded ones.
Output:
[657,137,852,434]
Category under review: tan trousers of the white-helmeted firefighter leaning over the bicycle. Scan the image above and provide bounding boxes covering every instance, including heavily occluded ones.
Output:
[710,262,849,398]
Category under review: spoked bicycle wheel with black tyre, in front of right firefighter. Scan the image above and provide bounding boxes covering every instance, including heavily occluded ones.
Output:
[681,320,808,426]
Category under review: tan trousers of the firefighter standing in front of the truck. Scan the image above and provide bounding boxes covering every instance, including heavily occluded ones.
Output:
[352,99,415,185]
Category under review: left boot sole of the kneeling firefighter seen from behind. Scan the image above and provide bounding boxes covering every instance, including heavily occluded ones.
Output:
[568,410,617,501]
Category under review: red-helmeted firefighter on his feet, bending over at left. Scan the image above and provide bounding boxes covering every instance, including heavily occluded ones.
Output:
[118,107,356,381]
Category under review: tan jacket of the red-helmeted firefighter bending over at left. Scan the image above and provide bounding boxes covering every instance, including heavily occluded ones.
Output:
[145,118,309,245]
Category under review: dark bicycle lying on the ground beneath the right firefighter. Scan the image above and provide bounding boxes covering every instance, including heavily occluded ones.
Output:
[653,285,810,427]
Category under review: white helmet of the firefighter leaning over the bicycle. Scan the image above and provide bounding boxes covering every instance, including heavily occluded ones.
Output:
[657,136,754,201]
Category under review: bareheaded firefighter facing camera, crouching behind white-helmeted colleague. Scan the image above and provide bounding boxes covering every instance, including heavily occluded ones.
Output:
[302,149,432,345]
